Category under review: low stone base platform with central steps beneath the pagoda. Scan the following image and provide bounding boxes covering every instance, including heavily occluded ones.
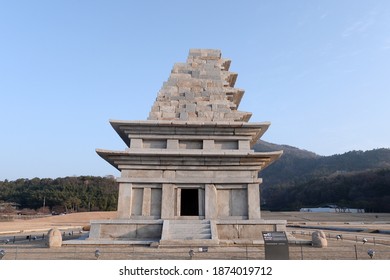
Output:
[76,219,287,247]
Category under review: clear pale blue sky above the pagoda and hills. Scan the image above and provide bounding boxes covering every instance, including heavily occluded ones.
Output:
[0,0,390,180]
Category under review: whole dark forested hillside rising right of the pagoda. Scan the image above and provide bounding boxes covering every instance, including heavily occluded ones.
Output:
[254,141,390,212]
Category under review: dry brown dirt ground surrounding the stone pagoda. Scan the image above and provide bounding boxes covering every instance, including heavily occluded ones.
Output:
[0,212,390,260]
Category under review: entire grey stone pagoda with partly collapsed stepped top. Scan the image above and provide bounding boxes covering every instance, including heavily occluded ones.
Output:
[88,49,286,246]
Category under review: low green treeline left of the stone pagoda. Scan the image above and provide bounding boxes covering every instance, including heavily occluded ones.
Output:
[0,176,118,213]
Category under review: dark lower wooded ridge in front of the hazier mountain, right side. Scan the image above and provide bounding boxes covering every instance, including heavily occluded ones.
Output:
[263,169,390,213]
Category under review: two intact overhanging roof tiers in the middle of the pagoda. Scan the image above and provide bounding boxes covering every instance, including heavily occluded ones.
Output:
[97,121,281,176]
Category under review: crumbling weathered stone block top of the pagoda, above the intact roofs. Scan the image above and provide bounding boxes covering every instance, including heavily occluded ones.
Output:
[149,49,249,121]
